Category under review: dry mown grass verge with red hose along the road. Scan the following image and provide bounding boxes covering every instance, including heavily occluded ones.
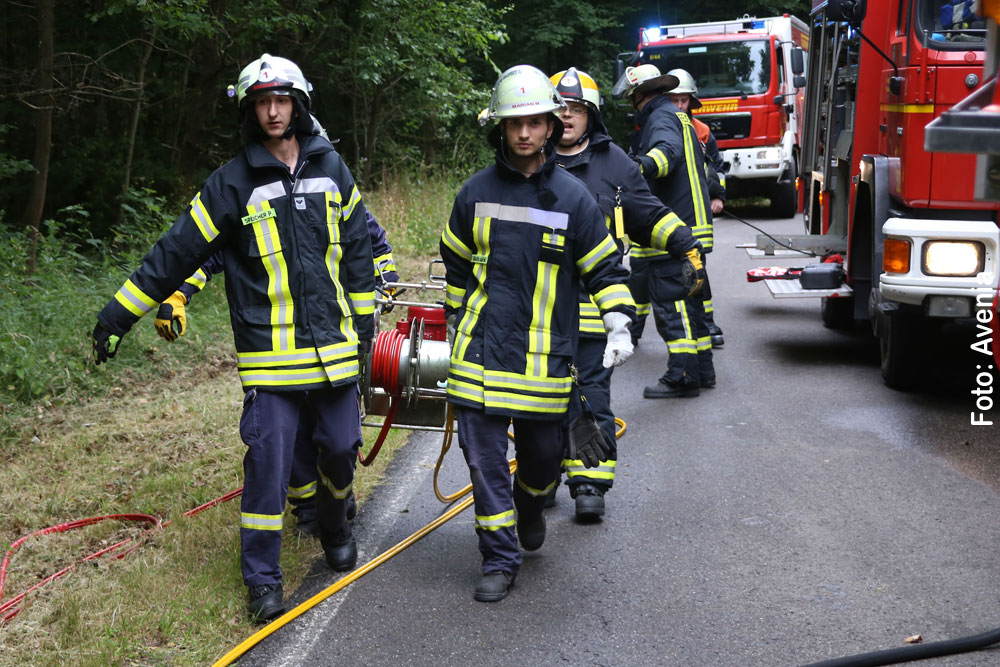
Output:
[0,171,457,667]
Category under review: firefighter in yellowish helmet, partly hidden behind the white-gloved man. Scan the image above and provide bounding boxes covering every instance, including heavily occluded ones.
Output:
[550,67,701,521]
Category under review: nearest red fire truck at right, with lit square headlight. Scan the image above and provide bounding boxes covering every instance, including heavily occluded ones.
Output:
[757,0,1000,388]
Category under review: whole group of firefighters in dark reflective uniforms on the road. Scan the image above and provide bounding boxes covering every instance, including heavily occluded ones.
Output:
[92,54,725,621]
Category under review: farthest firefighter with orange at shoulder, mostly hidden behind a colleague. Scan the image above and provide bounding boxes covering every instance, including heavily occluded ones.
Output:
[667,69,726,348]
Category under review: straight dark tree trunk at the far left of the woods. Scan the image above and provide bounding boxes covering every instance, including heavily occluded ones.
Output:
[24,0,55,273]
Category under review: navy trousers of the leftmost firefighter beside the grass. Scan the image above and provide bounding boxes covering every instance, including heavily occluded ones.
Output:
[240,384,361,586]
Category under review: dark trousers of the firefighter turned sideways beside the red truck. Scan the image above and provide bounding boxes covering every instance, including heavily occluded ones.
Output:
[649,259,715,387]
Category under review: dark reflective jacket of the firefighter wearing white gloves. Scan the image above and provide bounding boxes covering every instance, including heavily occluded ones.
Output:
[441,143,635,419]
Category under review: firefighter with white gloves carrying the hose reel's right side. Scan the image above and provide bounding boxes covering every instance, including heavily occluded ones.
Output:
[441,65,635,602]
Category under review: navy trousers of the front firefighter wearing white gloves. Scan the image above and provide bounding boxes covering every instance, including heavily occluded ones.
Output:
[455,406,562,574]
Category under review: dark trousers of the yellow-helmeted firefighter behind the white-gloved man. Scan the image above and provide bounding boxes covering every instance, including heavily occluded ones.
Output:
[563,336,618,493]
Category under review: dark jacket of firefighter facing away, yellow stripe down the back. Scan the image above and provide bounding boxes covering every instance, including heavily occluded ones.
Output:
[629,95,713,252]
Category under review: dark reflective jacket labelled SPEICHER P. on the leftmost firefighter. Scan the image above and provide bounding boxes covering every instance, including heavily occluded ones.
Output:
[98,135,375,391]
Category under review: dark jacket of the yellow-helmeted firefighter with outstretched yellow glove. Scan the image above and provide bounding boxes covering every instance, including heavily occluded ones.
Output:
[556,122,698,338]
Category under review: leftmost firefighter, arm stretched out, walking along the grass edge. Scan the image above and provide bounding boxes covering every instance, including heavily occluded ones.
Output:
[92,54,375,620]
